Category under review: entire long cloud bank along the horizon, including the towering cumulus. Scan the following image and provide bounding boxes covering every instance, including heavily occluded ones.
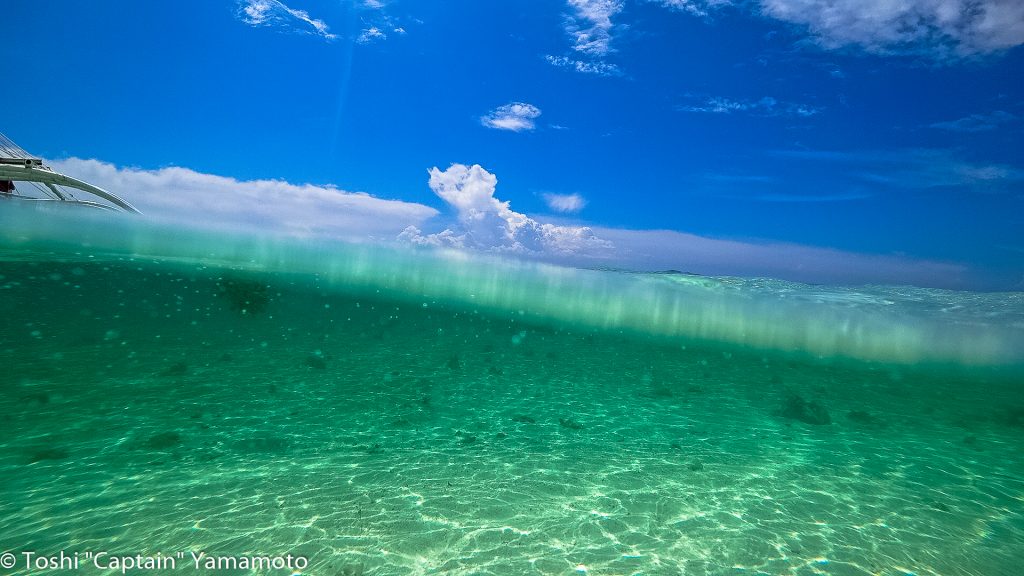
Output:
[49,158,971,287]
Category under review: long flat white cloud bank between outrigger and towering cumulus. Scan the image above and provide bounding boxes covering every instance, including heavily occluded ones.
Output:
[49,158,437,240]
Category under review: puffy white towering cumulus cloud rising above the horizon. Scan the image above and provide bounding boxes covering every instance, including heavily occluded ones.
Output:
[398,164,612,257]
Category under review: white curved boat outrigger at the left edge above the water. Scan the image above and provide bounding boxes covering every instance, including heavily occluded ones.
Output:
[0,133,138,214]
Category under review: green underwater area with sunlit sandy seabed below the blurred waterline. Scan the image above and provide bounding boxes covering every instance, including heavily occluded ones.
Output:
[0,261,1024,575]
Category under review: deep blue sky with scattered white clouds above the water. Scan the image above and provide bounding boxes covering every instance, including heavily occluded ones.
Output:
[0,0,1024,289]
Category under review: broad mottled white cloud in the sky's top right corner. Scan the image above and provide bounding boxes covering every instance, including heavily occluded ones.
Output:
[760,0,1024,56]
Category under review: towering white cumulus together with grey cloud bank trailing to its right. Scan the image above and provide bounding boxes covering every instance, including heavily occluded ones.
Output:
[398,164,973,288]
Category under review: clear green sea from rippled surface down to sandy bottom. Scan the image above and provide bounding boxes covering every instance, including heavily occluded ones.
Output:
[0,203,1024,576]
